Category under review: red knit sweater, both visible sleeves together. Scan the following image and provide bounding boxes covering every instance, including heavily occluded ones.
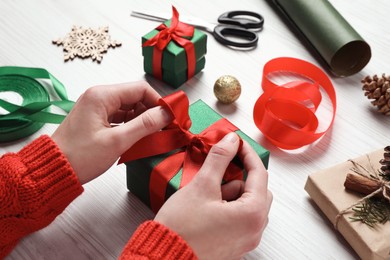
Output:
[0,136,196,259]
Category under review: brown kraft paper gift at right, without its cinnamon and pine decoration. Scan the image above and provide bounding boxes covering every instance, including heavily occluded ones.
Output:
[305,149,390,260]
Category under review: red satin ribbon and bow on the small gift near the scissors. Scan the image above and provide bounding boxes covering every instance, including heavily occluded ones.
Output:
[142,6,196,80]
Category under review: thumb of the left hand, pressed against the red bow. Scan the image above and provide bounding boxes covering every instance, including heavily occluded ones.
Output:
[111,106,173,152]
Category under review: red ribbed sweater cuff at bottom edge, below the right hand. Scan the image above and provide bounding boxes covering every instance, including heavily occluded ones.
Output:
[120,221,197,259]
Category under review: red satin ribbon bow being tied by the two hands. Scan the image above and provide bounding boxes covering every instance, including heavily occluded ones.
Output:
[119,91,243,212]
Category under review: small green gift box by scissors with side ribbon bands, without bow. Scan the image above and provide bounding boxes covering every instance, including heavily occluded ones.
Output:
[142,20,207,88]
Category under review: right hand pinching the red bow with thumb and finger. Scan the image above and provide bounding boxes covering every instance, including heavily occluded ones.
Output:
[155,133,272,259]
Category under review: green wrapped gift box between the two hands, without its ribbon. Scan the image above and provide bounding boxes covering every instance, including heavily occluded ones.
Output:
[125,100,270,211]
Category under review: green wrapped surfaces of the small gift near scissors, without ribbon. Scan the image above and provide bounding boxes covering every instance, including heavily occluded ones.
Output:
[142,20,207,88]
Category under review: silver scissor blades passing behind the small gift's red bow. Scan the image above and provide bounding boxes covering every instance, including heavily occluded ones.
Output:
[131,10,216,33]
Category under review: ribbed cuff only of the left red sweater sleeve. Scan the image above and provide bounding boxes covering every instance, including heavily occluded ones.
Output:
[18,135,84,221]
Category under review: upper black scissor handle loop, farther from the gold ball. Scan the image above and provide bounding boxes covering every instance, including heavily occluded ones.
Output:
[218,11,264,30]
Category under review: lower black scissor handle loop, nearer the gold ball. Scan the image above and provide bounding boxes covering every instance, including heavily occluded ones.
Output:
[214,25,258,48]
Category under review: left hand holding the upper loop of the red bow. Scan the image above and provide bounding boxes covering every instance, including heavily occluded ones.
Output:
[52,82,172,184]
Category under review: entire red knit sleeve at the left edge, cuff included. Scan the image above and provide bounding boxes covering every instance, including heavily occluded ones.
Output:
[0,135,83,259]
